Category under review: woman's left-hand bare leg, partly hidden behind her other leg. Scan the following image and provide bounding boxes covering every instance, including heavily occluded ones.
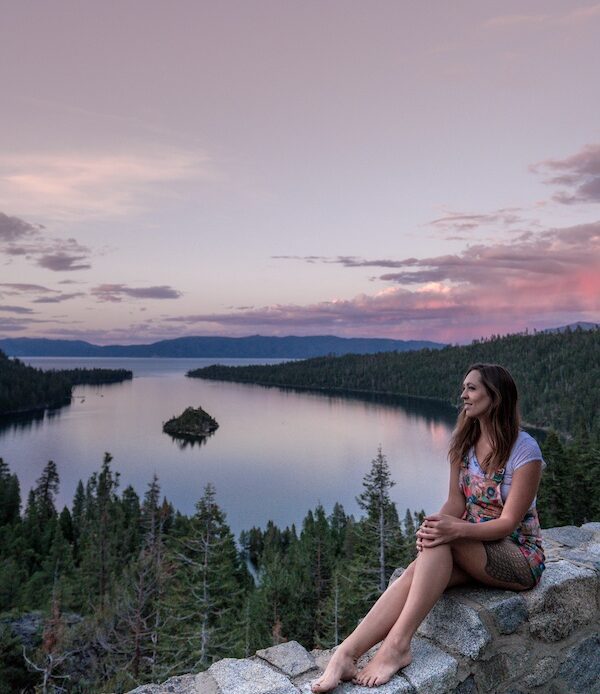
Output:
[312,557,469,692]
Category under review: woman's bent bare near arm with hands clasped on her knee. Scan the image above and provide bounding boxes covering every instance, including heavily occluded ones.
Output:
[417,460,542,547]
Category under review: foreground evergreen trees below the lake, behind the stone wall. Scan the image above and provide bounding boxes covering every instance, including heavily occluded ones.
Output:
[0,427,600,694]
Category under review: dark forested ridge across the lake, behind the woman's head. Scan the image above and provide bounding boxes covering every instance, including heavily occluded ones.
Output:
[188,329,600,434]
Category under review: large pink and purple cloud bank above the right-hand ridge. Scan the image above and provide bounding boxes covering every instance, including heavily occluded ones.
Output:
[167,222,600,340]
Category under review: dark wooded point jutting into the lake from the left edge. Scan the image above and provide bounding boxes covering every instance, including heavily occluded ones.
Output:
[0,351,133,416]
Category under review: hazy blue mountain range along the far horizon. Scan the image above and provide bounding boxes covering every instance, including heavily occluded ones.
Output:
[0,335,445,359]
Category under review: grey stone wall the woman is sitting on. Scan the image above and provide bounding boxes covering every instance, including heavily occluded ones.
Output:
[129,523,600,694]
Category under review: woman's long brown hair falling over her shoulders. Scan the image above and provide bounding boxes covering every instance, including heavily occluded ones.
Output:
[448,364,521,473]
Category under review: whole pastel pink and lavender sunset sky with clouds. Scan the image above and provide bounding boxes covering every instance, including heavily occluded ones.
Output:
[0,0,600,344]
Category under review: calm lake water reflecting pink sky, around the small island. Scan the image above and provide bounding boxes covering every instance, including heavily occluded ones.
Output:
[0,358,455,535]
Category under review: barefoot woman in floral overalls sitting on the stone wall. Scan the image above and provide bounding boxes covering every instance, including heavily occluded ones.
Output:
[312,364,544,692]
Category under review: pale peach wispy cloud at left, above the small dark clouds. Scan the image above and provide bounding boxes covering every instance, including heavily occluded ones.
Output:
[0,148,219,221]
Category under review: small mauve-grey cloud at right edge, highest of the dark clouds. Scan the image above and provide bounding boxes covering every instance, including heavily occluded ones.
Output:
[530,144,600,205]
